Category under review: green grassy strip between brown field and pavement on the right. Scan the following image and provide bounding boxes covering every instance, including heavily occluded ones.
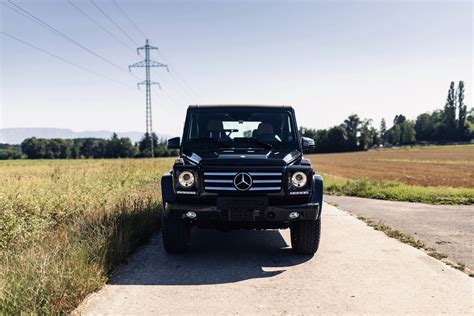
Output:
[324,175,474,205]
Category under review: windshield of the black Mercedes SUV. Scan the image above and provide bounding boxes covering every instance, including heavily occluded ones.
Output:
[184,108,297,149]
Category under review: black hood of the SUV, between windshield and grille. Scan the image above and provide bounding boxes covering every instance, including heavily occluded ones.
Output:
[184,149,301,166]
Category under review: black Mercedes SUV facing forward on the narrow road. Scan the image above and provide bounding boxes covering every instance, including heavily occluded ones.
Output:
[161,105,323,254]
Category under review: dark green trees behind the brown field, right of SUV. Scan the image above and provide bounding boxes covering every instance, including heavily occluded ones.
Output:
[300,81,474,153]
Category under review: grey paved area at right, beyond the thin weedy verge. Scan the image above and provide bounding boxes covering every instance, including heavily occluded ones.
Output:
[324,195,474,272]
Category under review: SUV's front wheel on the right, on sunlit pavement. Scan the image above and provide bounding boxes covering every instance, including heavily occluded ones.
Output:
[290,217,321,255]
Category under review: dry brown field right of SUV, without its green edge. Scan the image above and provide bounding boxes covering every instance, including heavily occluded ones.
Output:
[307,145,474,188]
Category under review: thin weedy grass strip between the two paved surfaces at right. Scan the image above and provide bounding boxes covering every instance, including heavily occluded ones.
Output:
[357,216,474,277]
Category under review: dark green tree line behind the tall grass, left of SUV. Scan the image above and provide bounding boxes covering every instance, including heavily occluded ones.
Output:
[0,133,178,159]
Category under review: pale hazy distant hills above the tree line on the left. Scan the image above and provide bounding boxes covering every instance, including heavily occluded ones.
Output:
[0,128,170,144]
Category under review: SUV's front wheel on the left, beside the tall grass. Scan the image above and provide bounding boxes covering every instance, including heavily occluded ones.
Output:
[162,211,191,253]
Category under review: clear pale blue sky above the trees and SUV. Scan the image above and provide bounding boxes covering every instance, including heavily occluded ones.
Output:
[0,0,473,135]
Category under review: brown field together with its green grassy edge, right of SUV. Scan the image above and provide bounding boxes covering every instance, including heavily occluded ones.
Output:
[307,145,474,204]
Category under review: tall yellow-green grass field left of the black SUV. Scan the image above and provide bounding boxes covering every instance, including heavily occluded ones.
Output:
[0,159,171,314]
